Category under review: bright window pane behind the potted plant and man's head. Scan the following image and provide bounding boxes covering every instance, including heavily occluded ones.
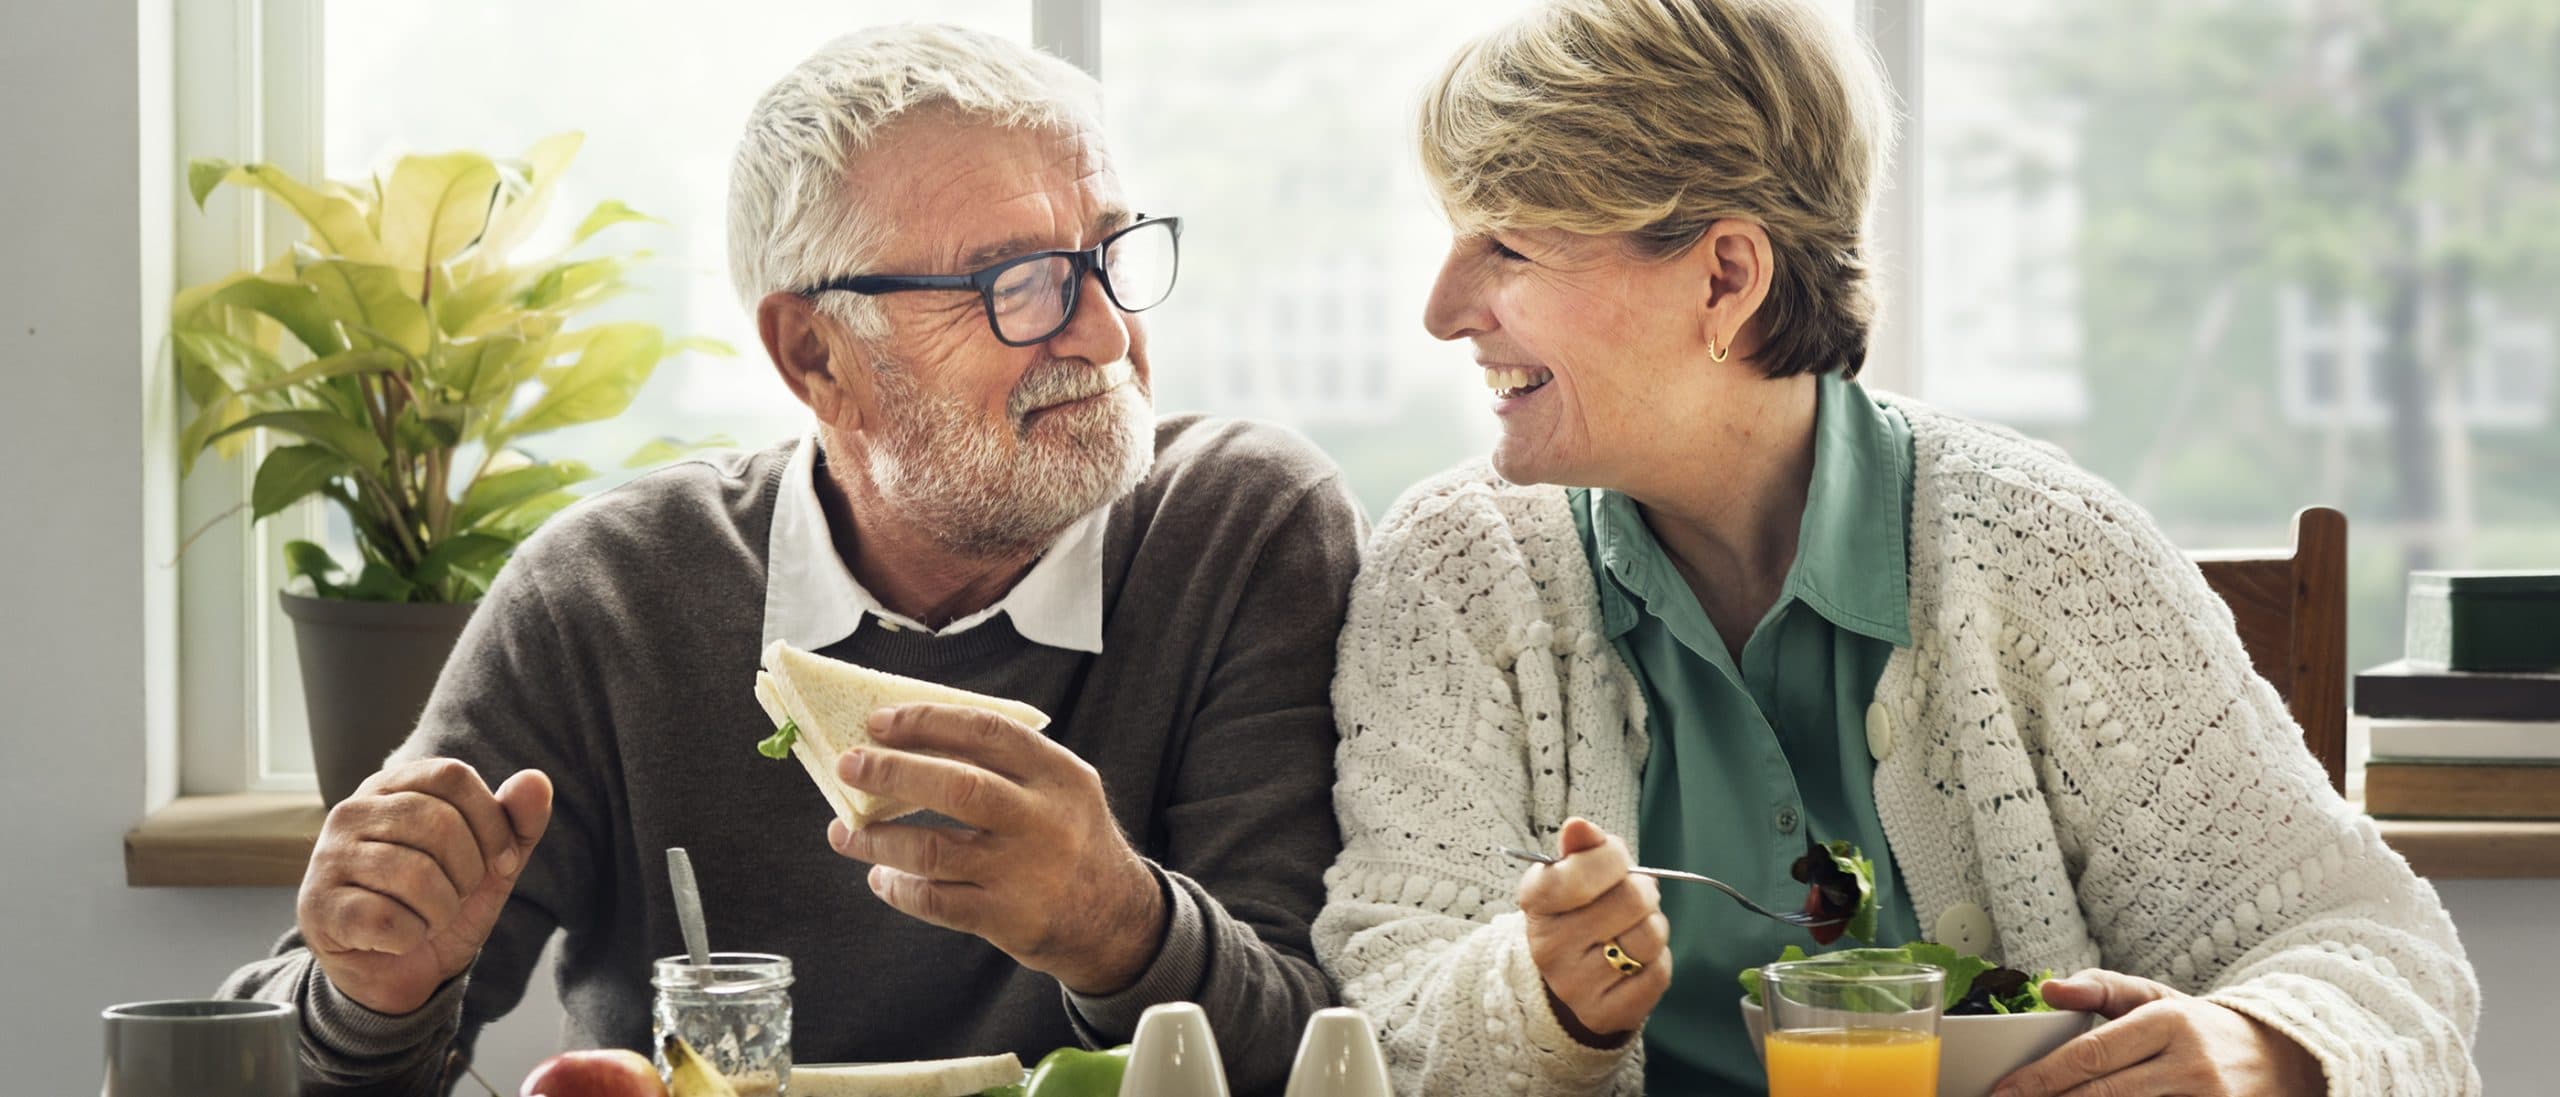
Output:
[314,0,1032,772]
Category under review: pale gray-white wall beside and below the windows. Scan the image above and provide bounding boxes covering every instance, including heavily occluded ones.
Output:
[0,0,2560,1094]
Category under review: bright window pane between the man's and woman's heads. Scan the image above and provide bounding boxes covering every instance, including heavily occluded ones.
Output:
[1103,0,1526,511]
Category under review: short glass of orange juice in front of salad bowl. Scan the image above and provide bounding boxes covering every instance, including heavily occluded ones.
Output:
[1761,959,1946,1097]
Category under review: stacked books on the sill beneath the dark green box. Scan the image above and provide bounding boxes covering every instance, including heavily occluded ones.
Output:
[2355,660,2560,818]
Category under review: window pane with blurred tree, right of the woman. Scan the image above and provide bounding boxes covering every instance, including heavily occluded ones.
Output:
[1917,0,2560,665]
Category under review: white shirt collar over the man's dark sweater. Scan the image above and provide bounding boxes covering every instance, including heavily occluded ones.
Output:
[758,435,1111,652]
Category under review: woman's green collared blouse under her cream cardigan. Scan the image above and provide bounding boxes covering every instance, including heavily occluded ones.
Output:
[1572,373,1920,1094]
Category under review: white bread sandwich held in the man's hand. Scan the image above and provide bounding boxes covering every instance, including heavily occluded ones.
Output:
[755,639,1050,826]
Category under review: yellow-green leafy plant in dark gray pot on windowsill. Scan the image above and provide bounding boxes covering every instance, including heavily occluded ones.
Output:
[172,133,727,803]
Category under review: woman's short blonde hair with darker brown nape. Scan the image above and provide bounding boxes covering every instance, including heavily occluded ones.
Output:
[1421,0,1892,376]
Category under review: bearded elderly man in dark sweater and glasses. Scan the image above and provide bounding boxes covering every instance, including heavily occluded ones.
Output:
[228,28,1362,1092]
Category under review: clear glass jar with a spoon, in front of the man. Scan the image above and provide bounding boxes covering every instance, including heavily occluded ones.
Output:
[650,951,791,1097]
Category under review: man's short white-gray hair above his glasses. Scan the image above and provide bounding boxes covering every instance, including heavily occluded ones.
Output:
[730,23,1101,338]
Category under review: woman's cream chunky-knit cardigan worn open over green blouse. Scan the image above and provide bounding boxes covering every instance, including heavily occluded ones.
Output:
[1316,401,2481,1097]
